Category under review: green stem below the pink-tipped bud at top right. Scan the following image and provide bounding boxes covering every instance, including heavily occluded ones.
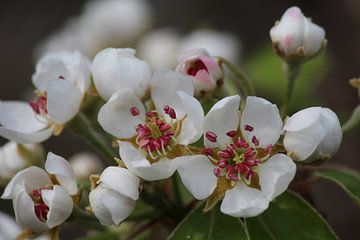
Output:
[281,62,300,117]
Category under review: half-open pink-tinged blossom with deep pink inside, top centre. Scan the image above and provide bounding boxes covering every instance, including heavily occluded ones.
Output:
[176,48,223,96]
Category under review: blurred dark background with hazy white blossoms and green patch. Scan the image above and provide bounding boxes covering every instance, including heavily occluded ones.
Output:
[0,0,360,239]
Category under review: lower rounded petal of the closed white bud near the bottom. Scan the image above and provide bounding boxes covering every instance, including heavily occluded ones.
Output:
[89,184,135,225]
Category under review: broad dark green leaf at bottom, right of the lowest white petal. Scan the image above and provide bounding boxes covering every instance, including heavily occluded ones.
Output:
[246,192,338,240]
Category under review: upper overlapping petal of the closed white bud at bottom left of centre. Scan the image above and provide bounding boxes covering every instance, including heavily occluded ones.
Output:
[100,167,140,200]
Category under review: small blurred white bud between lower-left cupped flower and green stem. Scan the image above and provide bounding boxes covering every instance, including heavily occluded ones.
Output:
[69,152,103,180]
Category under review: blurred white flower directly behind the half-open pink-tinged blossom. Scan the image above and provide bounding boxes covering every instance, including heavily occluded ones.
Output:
[179,29,241,62]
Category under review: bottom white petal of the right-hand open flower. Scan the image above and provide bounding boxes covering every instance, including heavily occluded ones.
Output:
[220,183,269,218]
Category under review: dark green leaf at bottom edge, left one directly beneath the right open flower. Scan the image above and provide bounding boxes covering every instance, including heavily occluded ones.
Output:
[168,204,248,240]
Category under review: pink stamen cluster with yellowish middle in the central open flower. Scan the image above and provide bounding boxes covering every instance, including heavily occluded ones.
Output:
[130,106,182,160]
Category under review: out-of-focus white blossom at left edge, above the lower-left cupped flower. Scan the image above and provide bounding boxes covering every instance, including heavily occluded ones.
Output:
[0,142,44,181]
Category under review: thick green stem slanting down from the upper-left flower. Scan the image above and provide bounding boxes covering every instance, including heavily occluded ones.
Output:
[69,113,116,165]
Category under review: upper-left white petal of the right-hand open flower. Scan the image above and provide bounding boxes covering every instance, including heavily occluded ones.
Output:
[204,95,240,148]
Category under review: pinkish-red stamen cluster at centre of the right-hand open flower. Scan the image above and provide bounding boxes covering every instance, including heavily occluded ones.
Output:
[204,125,272,188]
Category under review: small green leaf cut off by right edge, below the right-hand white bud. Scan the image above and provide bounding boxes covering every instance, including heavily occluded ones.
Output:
[315,169,360,206]
